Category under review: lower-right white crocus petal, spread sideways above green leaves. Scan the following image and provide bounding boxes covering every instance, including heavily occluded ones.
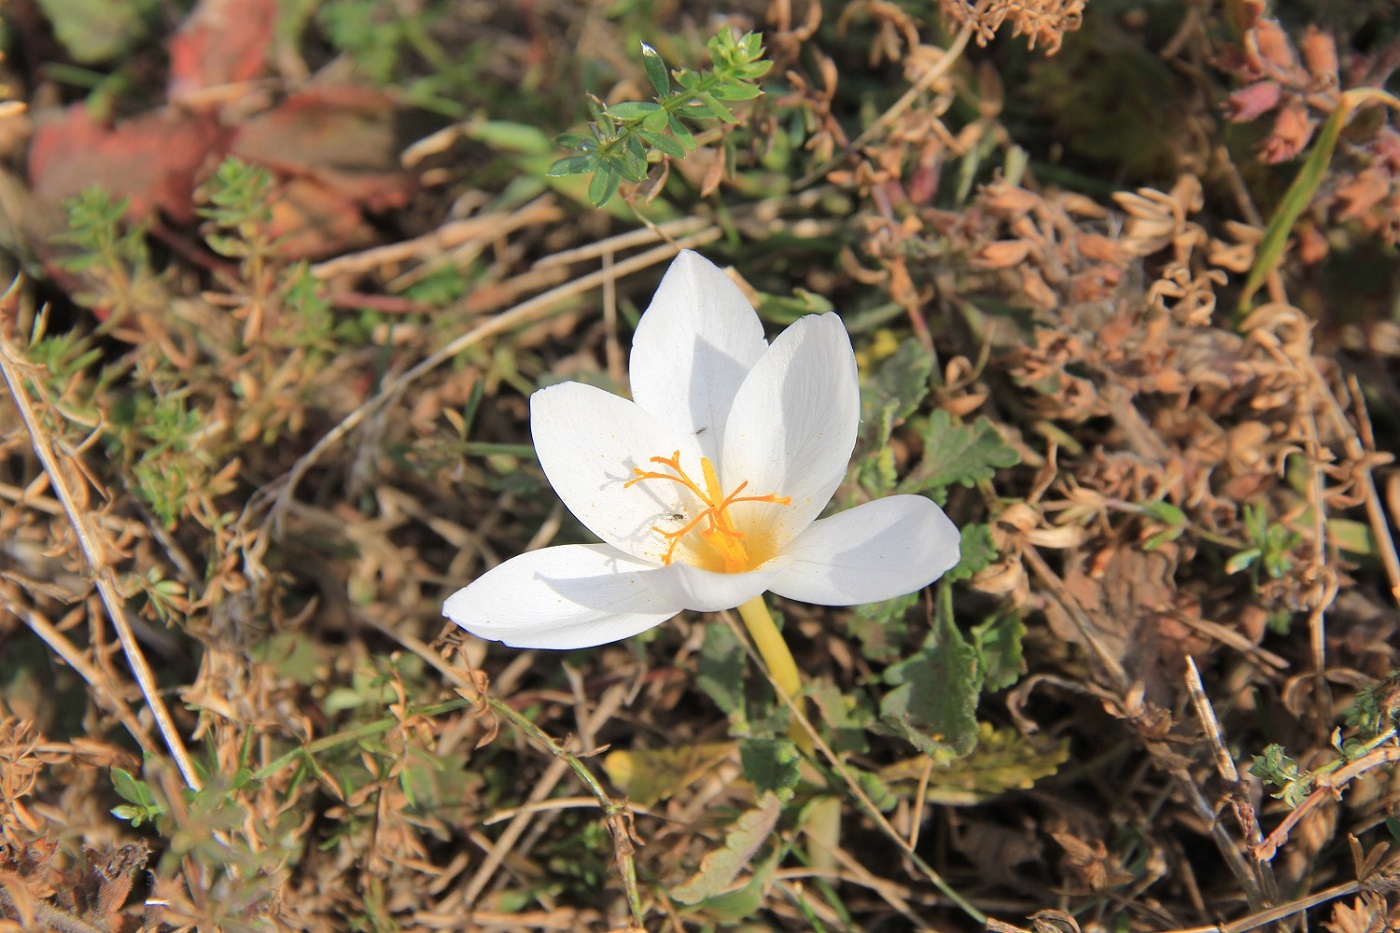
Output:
[770,496,960,605]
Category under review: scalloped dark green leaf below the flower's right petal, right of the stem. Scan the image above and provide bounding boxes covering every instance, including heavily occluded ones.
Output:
[878,599,981,762]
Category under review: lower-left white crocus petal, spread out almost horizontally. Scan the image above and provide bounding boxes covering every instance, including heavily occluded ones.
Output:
[442,545,680,649]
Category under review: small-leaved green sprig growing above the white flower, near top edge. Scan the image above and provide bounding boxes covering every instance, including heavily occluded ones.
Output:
[547,29,773,207]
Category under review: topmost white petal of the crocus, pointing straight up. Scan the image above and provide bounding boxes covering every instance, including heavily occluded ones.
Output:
[630,249,769,462]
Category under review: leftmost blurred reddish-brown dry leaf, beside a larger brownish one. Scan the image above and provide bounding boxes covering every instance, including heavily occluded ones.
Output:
[29,104,227,224]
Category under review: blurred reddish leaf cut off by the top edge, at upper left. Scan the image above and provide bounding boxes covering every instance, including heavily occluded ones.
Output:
[168,0,277,101]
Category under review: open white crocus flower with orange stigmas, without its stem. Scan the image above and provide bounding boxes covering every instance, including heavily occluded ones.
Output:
[442,252,959,649]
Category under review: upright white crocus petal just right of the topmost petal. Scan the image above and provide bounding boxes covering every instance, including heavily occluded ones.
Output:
[720,314,861,548]
